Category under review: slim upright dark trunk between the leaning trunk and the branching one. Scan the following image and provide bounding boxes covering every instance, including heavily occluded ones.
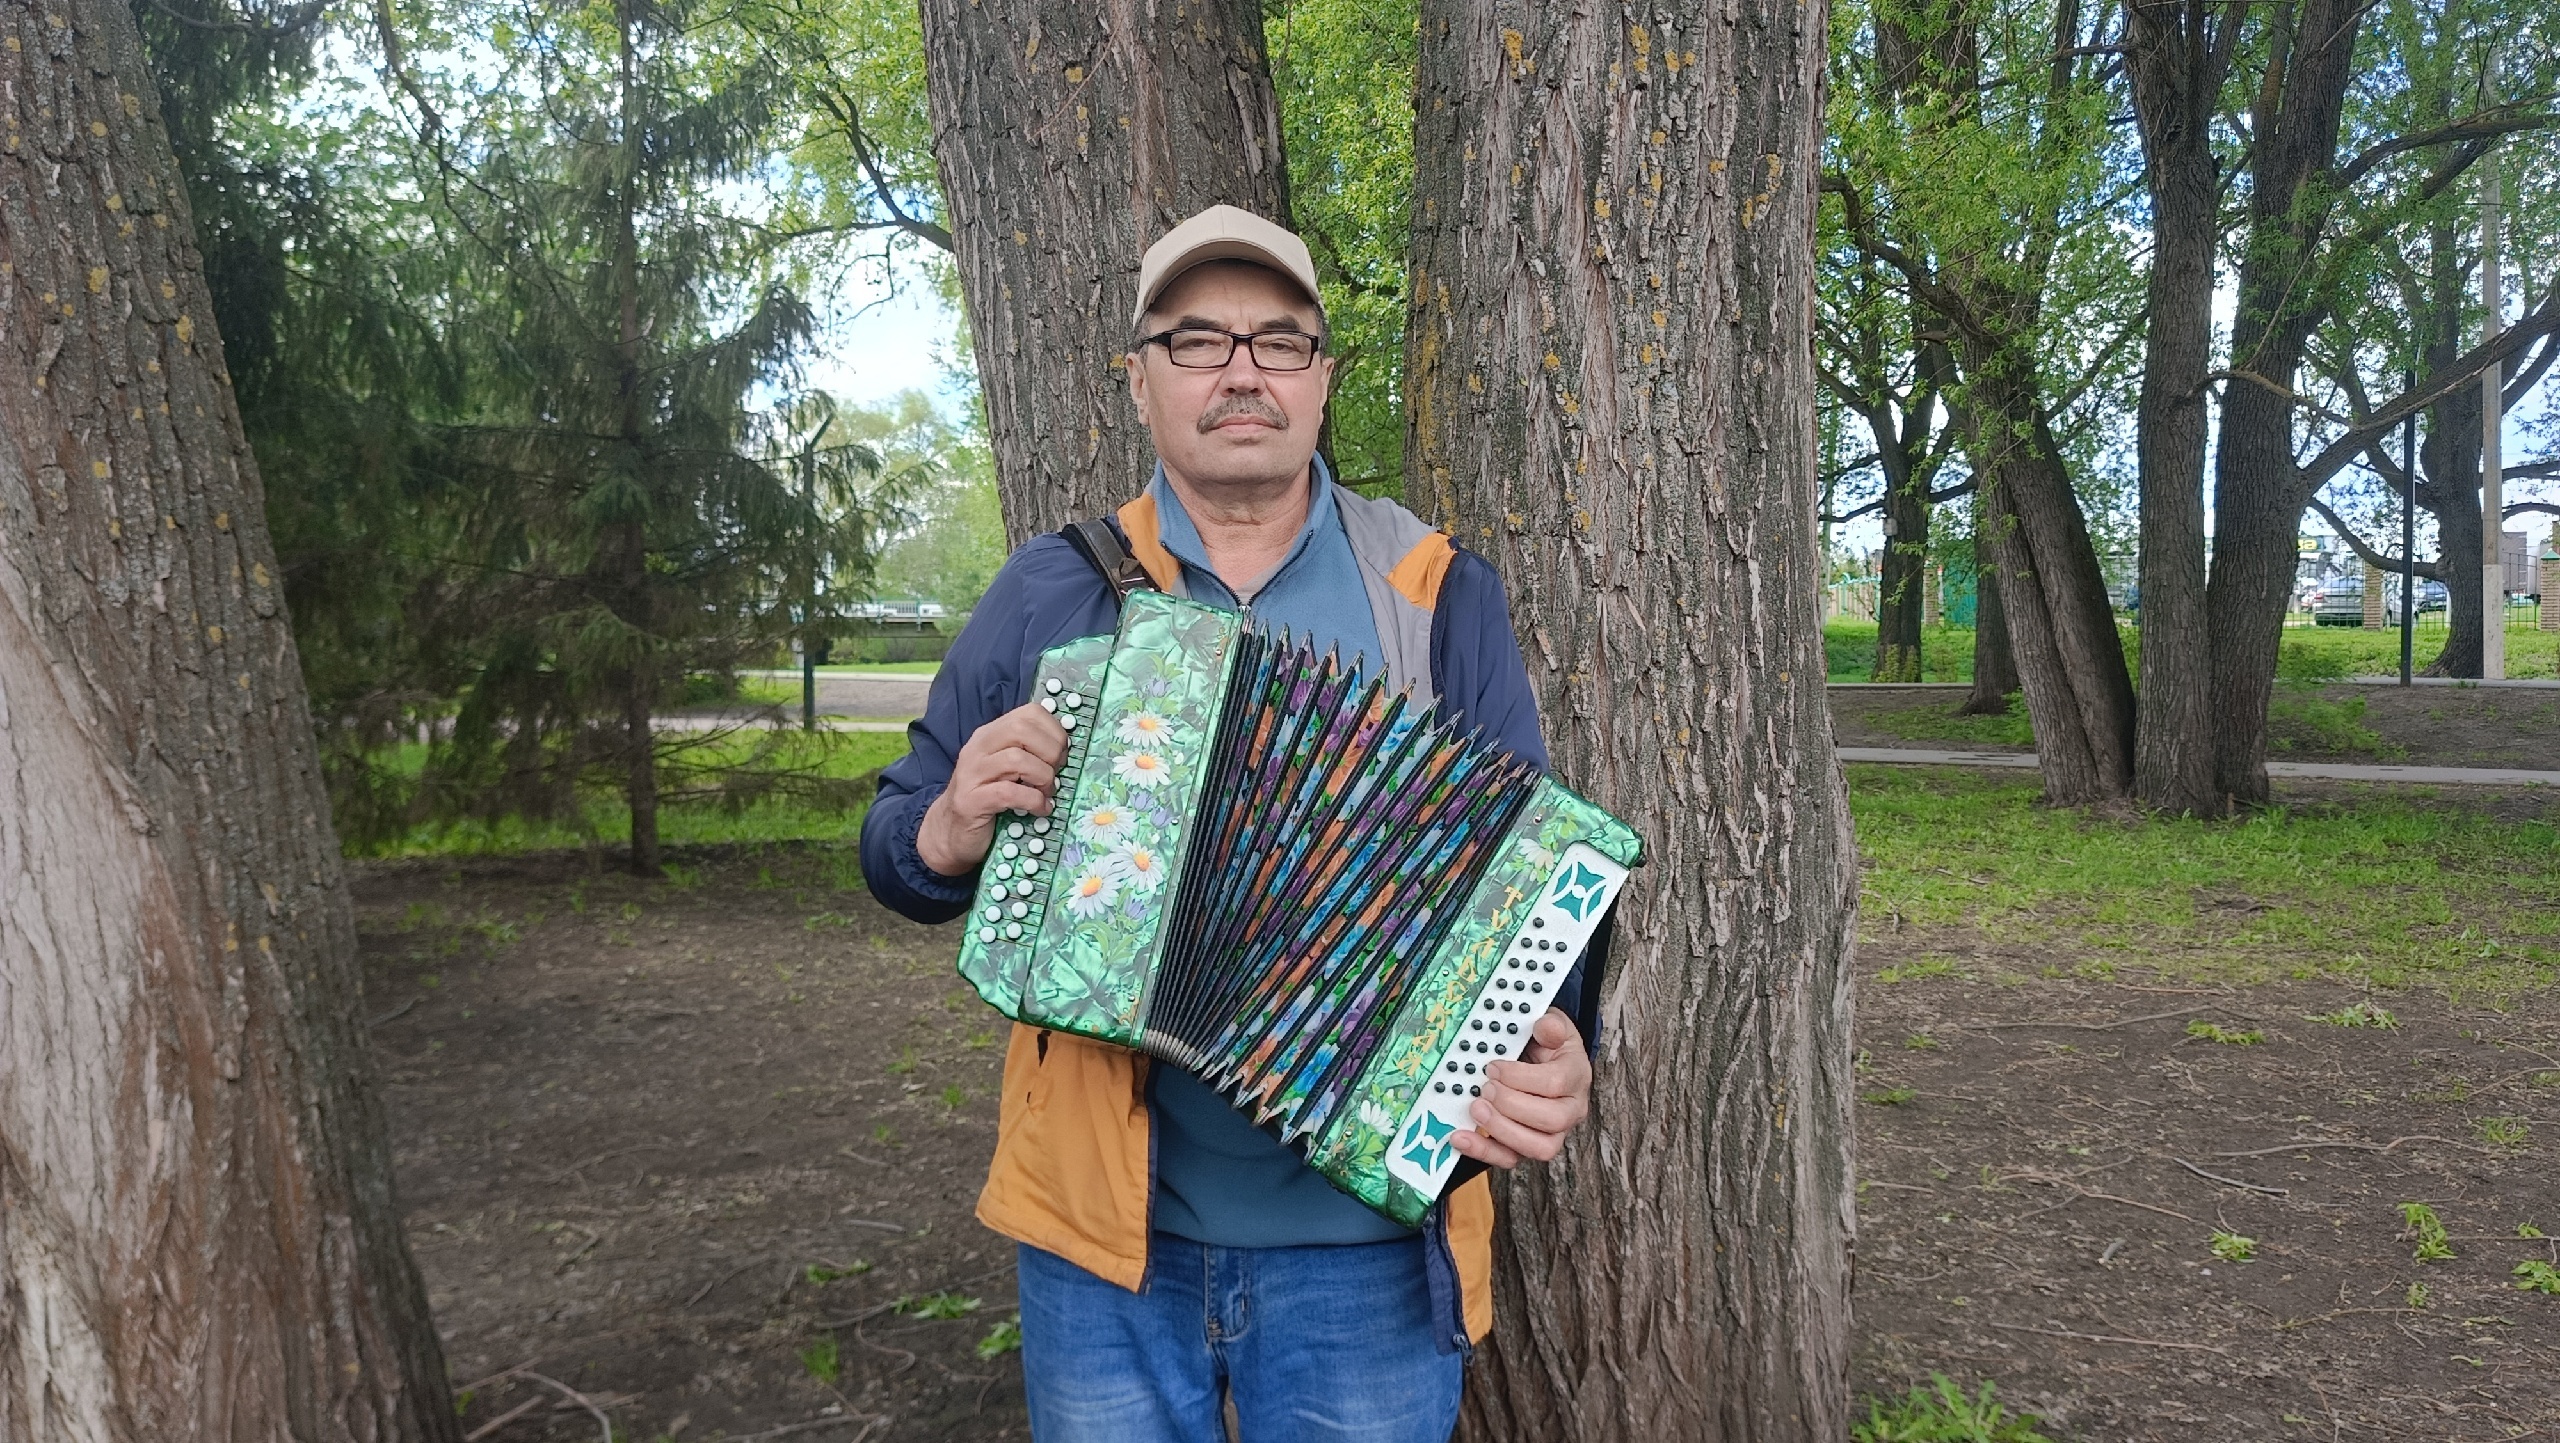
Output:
[2125,0,2240,816]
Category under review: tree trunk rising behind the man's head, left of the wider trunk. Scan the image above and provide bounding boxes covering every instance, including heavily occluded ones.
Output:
[924,0,1288,545]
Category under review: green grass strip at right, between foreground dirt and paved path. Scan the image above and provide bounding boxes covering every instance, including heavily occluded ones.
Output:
[1848,765,2560,1000]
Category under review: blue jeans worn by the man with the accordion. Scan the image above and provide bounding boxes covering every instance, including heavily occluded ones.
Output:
[1019,1233,1467,1443]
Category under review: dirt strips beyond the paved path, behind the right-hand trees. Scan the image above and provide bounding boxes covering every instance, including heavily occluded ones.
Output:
[1830,683,2560,770]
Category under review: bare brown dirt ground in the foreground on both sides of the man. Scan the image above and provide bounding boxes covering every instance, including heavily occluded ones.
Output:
[371,798,2560,1443]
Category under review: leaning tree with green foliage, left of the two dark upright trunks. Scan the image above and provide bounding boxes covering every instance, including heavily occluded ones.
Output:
[1825,0,2140,803]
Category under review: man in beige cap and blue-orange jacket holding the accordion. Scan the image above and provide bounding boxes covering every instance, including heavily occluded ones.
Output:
[863,205,1590,1443]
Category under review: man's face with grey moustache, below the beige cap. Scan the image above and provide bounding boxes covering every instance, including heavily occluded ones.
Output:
[1129,261,1334,486]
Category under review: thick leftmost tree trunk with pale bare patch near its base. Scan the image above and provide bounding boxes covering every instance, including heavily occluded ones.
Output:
[0,0,461,1443]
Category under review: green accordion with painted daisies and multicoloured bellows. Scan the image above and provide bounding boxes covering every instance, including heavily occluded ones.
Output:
[960,591,1641,1226]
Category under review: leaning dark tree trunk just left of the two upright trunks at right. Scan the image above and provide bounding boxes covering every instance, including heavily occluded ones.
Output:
[1958,351,2132,806]
